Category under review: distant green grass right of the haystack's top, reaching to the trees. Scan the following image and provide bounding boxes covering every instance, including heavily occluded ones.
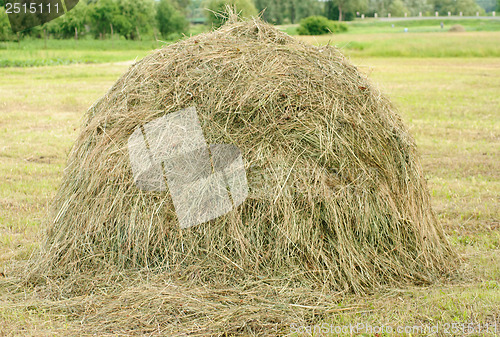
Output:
[279,18,500,58]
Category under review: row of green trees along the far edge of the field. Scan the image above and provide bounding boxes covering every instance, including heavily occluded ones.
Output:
[0,0,500,40]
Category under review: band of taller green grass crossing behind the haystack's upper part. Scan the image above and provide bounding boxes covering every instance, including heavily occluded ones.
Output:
[0,32,500,68]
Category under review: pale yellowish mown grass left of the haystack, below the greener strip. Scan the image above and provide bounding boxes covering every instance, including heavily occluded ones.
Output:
[0,65,126,260]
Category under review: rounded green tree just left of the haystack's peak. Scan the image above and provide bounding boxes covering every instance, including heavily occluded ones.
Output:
[156,0,188,38]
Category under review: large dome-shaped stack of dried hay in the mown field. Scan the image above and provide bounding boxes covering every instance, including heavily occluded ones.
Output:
[34,19,453,293]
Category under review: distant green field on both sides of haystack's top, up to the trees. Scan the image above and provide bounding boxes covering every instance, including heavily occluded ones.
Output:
[0,19,500,68]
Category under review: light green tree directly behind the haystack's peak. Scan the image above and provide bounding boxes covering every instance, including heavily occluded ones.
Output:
[205,0,257,27]
